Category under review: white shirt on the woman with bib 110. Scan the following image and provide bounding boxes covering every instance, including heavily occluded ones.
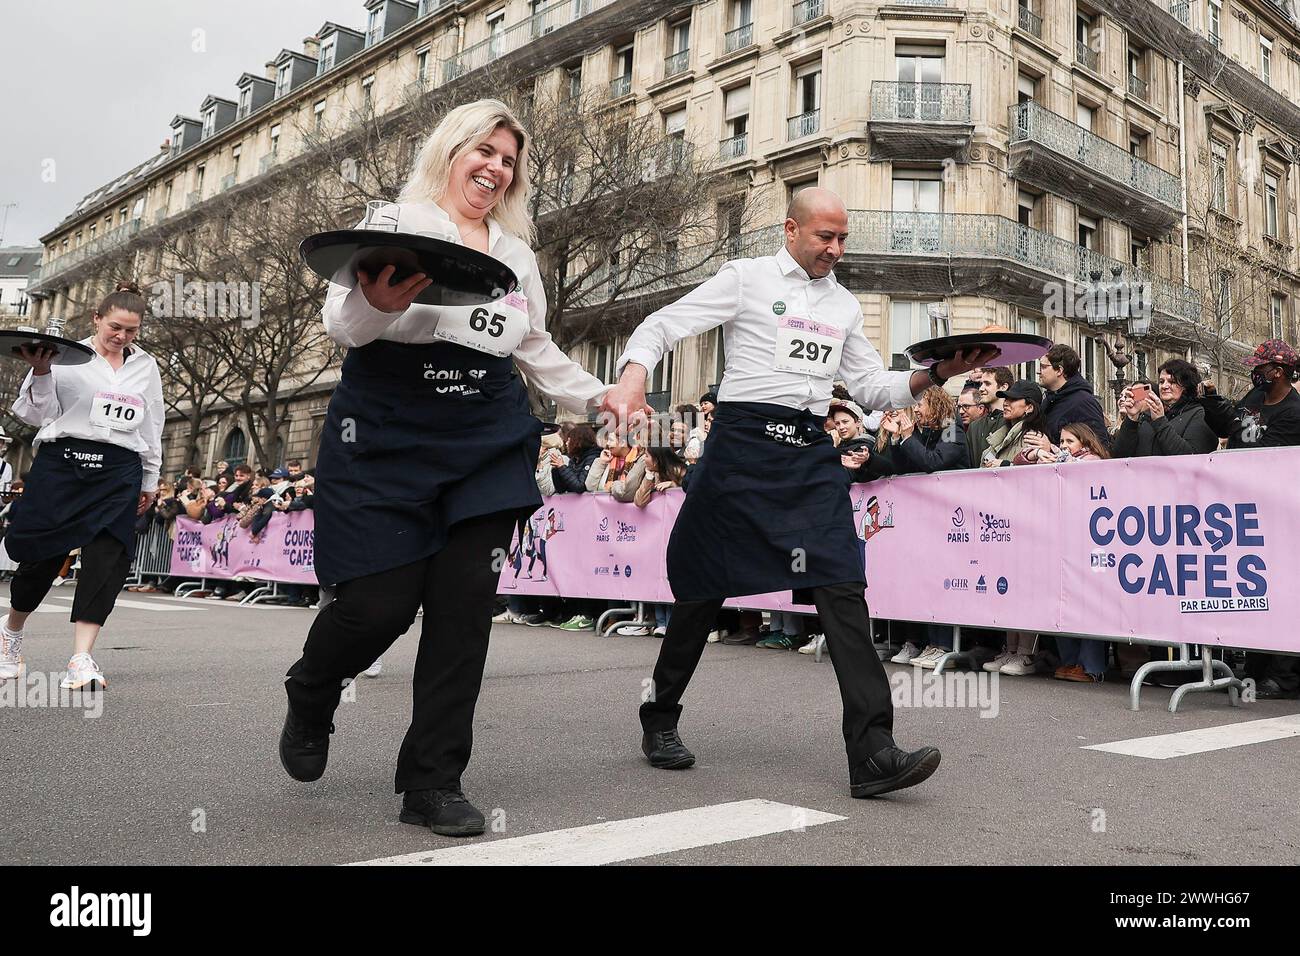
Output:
[13,337,166,492]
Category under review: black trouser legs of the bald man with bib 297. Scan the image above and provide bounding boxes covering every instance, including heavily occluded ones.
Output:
[641,583,894,773]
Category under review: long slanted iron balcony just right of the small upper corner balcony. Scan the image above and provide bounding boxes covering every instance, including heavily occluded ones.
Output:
[1008,101,1183,233]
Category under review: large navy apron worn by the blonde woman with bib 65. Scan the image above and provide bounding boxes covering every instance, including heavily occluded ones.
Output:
[315,341,542,587]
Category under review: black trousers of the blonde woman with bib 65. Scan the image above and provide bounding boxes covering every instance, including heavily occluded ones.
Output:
[285,511,515,793]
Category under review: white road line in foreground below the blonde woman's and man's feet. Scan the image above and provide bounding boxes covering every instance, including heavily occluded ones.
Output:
[351,800,844,866]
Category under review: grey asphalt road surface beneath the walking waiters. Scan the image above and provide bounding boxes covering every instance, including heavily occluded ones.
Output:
[0,587,1300,865]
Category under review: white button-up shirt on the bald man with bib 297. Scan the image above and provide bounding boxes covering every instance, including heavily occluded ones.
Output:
[618,248,917,415]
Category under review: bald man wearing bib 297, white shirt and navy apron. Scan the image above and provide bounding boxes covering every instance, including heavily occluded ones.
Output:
[602,189,996,797]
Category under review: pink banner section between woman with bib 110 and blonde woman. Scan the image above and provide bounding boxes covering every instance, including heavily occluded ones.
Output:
[172,511,316,584]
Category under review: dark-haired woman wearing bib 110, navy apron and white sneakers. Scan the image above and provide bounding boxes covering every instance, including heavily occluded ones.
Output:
[0,282,165,689]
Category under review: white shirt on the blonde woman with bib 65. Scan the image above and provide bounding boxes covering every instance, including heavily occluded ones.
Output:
[321,203,611,412]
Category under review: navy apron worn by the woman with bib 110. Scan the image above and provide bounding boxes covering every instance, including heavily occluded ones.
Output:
[4,438,144,561]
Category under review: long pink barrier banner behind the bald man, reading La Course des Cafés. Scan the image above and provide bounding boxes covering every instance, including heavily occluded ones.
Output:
[499,449,1300,652]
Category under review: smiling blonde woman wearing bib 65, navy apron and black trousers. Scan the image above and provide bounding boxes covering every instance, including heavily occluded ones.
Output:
[280,100,610,836]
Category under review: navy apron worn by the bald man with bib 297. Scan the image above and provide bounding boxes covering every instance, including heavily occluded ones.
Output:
[668,402,866,604]
